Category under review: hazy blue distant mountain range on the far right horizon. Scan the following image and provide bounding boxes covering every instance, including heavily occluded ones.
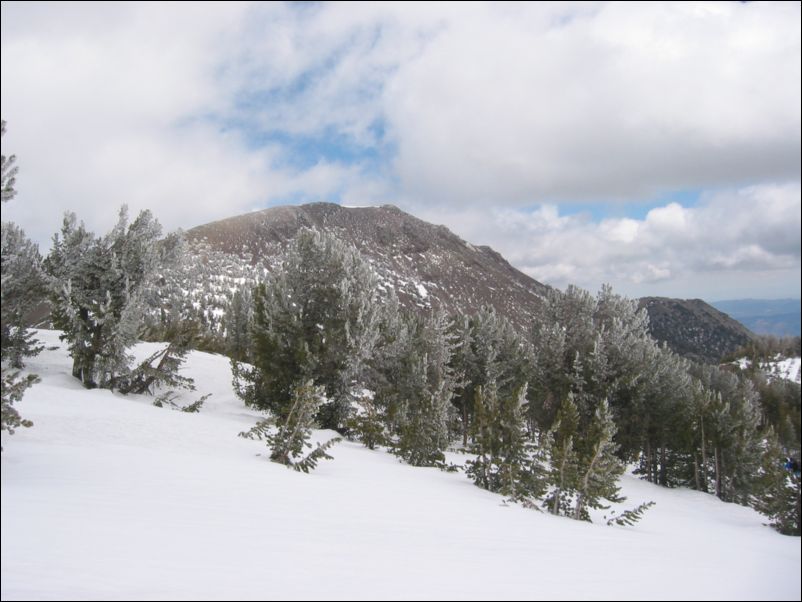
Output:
[711,299,802,337]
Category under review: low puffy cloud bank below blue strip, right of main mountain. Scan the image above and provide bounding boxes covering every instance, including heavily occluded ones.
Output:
[421,183,802,299]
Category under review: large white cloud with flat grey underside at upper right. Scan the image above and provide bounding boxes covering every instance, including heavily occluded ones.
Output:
[386,3,800,204]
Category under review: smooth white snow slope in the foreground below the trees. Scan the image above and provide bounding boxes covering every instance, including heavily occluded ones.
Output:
[2,331,800,600]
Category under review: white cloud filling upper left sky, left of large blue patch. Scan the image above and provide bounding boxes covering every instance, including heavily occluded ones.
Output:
[2,2,378,244]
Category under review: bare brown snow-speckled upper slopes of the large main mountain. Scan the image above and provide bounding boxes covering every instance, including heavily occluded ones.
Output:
[187,203,550,326]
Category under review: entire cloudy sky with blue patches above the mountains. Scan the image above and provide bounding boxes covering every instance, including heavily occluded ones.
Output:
[2,2,802,300]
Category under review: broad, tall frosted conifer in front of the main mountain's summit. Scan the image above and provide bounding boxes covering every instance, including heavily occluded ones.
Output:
[235,230,379,429]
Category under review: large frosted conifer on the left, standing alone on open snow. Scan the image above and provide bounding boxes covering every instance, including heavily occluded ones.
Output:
[45,207,161,388]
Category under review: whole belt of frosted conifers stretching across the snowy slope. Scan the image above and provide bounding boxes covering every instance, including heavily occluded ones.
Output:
[2,119,800,534]
